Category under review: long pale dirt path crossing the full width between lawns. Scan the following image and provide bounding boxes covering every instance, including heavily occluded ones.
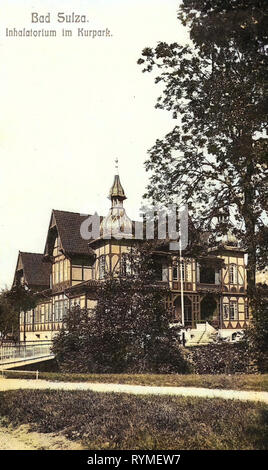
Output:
[0,378,268,404]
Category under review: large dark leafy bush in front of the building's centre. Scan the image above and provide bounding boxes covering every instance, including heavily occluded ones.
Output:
[53,244,191,373]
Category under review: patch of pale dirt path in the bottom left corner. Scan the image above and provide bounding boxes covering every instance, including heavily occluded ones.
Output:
[0,424,83,450]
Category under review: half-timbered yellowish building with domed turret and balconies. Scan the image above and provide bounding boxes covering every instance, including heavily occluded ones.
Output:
[13,174,249,341]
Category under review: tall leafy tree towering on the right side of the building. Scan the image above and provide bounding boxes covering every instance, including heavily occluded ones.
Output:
[138,0,268,308]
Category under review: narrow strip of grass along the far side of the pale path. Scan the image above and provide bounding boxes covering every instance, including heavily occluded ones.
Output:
[5,370,268,391]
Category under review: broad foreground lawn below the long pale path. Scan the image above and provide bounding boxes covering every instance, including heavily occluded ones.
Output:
[0,390,268,450]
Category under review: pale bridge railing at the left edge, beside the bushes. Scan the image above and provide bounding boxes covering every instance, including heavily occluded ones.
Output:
[0,342,52,363]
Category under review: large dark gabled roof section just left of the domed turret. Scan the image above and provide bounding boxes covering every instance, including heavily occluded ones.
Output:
[45,209,94,256]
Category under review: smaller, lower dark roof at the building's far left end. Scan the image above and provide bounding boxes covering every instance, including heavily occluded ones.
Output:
[17,251,51,287]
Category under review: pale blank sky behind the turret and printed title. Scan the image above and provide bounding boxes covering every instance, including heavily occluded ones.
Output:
[0,0,188,288]
